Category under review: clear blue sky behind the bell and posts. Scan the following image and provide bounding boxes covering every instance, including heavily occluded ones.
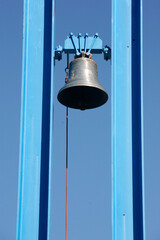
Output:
[0,0,160,240]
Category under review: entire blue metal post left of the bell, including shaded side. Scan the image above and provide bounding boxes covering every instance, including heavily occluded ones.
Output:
[16,0,54,240]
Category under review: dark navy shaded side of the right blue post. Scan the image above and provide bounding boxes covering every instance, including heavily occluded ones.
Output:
[132,0,144,240]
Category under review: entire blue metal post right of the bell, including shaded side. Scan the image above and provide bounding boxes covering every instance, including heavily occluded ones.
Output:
[112,0,145,240]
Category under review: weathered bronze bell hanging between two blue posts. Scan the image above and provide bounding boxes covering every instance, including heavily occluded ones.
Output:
[57,57,108,110]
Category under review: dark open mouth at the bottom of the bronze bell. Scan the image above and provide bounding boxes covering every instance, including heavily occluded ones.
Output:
[57,85,108,110]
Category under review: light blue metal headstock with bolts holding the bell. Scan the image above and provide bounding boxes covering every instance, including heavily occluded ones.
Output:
[55,33,111,61]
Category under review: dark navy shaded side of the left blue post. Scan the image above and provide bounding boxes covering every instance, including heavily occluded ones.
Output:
[39,0,53,240]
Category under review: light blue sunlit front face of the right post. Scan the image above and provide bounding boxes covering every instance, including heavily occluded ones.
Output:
[112,0,133,240]
